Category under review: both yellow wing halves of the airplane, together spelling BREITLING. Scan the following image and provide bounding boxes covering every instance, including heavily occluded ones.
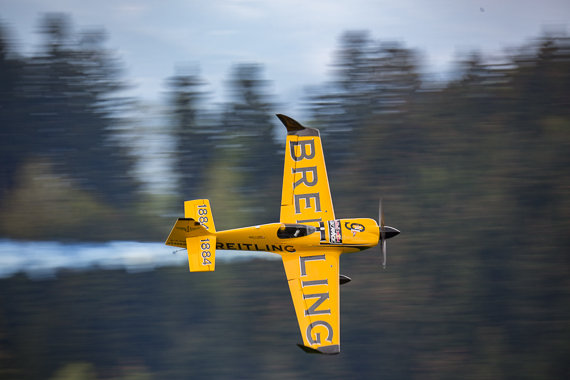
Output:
[277,115,341,354]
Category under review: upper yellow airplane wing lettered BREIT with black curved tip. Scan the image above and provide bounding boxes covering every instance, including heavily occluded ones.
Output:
[277,115,334,223]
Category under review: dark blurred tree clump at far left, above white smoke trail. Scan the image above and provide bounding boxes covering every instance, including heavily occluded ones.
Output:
[0,14,138,240]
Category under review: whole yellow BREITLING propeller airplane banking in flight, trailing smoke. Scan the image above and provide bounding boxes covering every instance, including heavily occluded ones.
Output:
[166,115,400,354]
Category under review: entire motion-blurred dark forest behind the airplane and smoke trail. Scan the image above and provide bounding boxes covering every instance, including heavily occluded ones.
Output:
[0,14,570,380]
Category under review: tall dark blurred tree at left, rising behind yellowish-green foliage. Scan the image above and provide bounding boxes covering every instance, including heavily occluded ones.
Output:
[22,14,136,206]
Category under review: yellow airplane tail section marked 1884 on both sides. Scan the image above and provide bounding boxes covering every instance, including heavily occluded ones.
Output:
[166,199,216,272]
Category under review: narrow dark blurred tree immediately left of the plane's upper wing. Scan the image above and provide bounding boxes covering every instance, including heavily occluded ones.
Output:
[214,64,283,223]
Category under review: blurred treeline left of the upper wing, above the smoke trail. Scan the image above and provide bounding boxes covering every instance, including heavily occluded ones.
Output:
[0,14,282,241]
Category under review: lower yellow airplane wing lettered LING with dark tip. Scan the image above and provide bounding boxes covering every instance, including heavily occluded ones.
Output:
[282,250,340,354]
